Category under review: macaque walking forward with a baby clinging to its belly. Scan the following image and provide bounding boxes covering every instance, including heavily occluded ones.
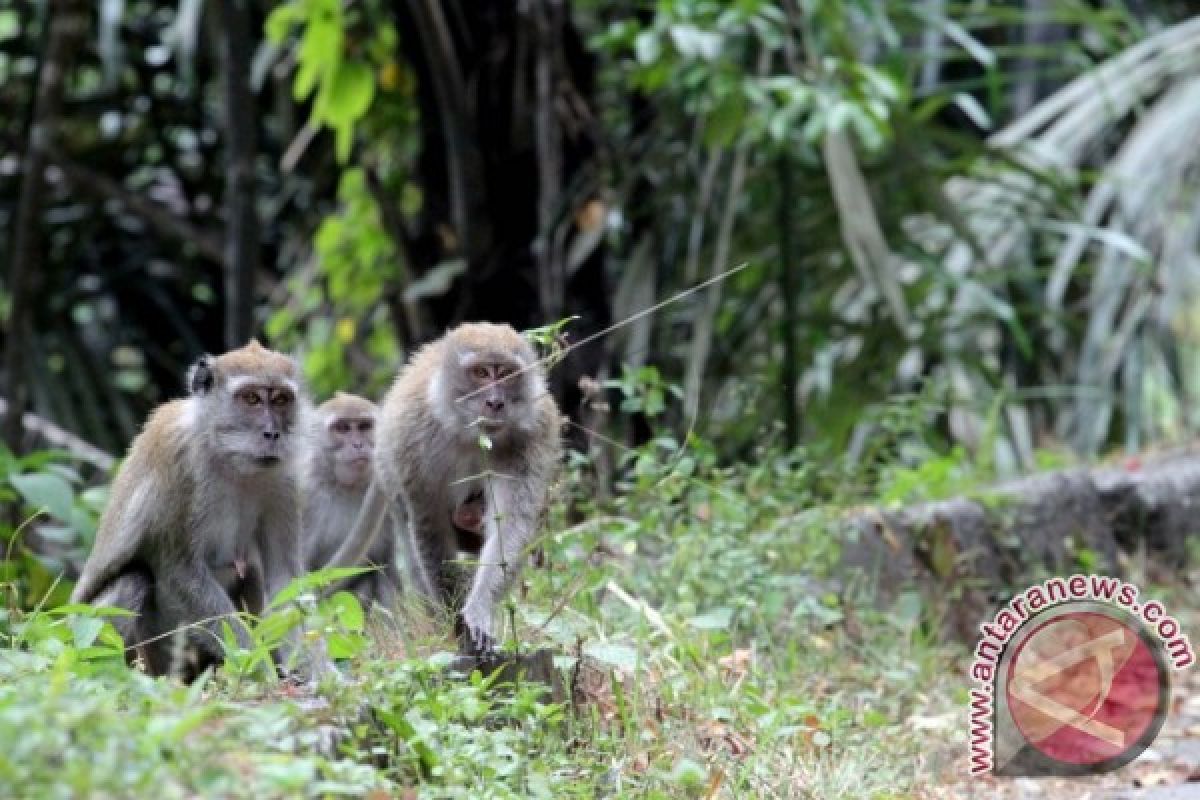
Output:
[334,323,562,655]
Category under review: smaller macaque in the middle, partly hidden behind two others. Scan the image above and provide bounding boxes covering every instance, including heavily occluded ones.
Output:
[301,392,403,609]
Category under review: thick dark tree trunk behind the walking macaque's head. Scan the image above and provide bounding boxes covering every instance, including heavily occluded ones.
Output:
[392,0,611,411]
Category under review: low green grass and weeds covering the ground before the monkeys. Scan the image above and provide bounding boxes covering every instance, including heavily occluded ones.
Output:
[0,443,1012,800]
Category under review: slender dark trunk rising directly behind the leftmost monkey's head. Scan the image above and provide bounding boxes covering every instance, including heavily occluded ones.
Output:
[216,0,259,349]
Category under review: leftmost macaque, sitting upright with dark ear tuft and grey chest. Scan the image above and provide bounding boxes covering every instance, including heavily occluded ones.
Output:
[72,342,307,680]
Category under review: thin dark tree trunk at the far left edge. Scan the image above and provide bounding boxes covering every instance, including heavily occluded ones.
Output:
[4,0,88,451]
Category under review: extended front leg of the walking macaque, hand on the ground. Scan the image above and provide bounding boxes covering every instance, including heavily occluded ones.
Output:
[462,479,540,655]
